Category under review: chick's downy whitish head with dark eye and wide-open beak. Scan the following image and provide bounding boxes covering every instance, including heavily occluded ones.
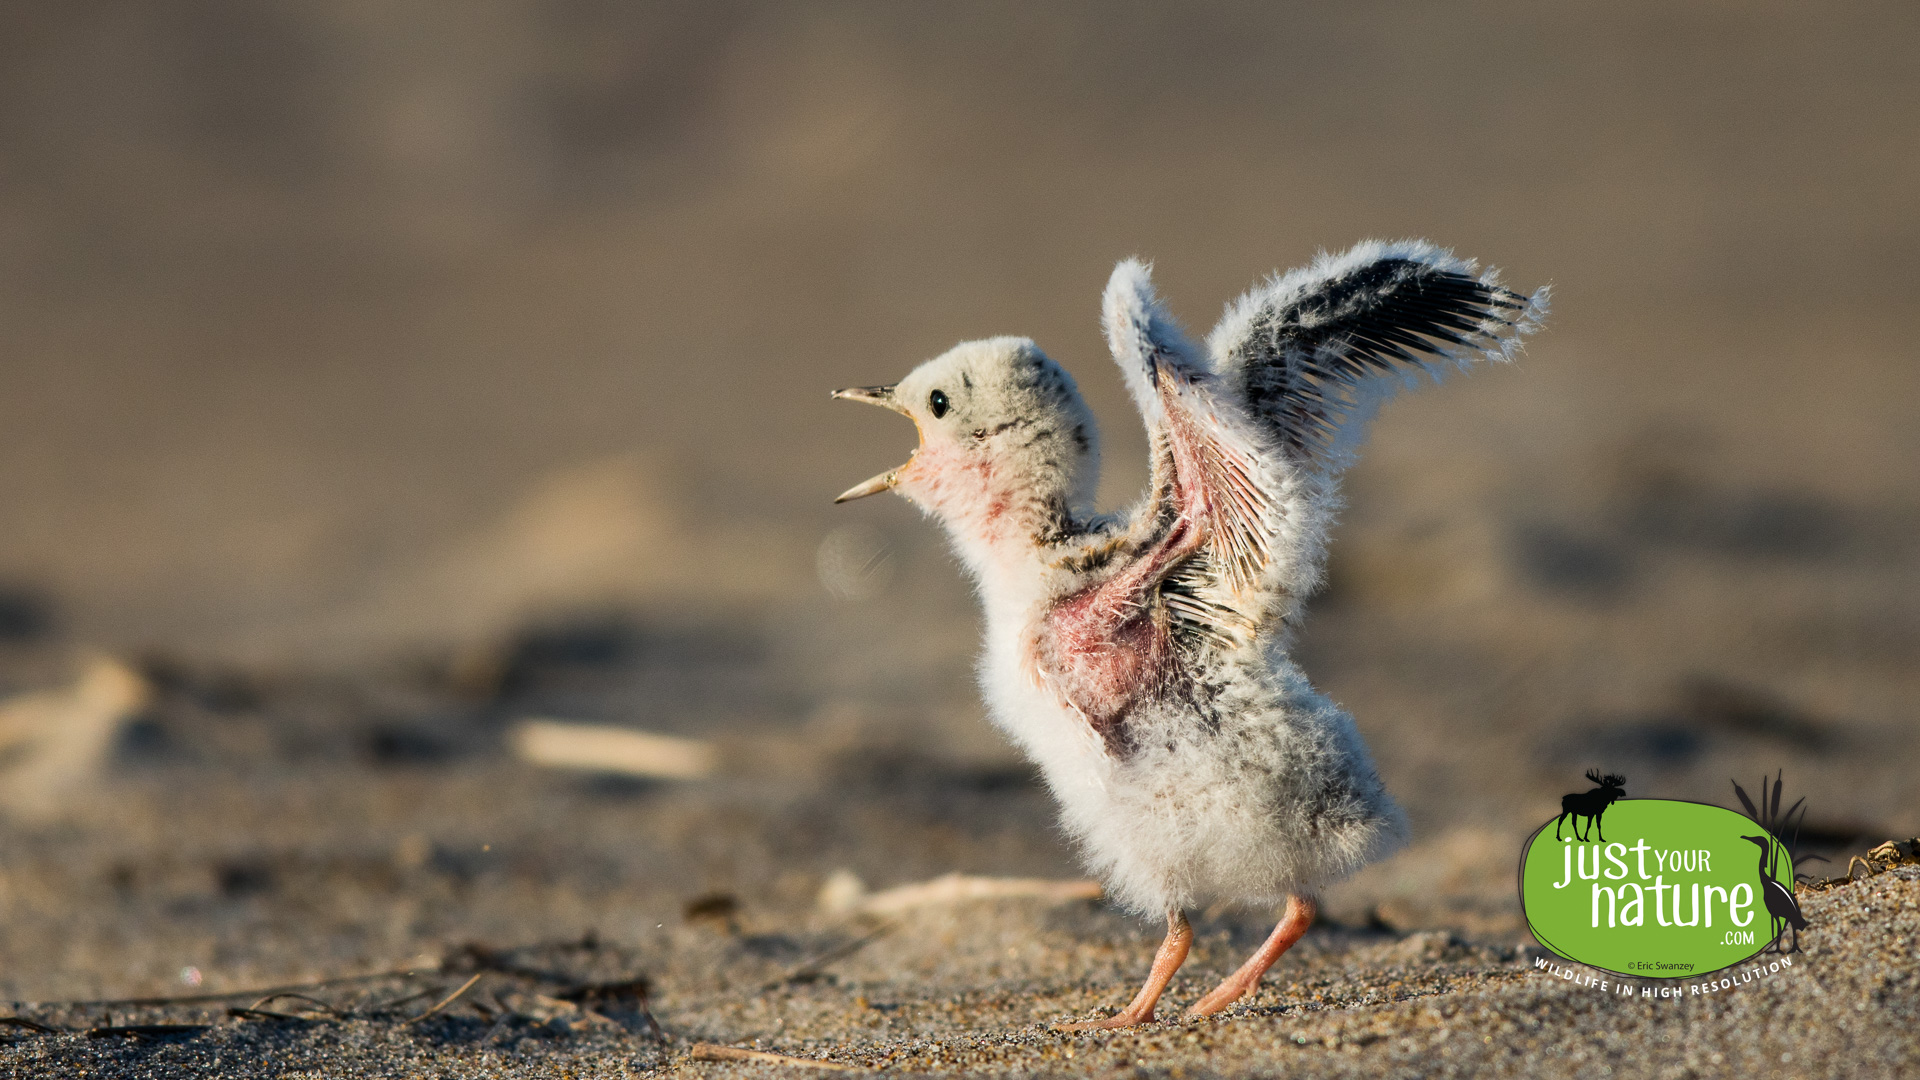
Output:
[833,338,1100,559]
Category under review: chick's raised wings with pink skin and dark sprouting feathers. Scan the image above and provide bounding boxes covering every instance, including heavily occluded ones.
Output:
[1104,240,1546,648]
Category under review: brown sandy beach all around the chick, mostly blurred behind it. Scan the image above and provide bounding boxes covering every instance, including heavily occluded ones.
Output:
[0,0,1920,1078]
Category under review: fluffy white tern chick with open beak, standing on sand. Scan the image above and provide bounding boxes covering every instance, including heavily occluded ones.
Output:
[835,240,1548,1028]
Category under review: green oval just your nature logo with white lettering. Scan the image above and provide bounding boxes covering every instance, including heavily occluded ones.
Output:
[1521,799,1797,978]
